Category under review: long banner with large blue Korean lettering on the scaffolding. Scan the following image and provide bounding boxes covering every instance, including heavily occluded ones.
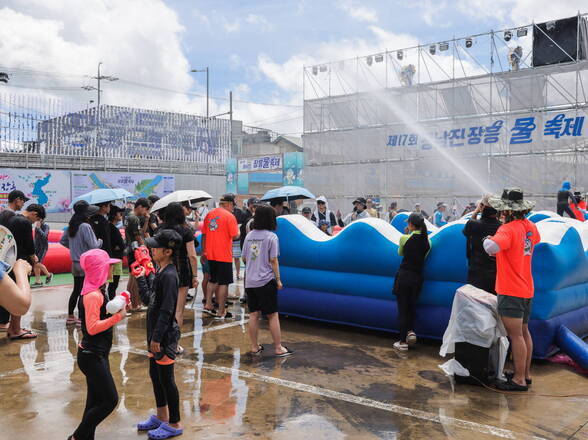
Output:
[386,111,588,150]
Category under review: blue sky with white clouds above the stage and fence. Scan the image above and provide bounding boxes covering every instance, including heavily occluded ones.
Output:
[0,0,588,136]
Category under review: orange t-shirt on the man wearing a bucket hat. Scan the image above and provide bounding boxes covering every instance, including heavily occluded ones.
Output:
[491,220,541,298]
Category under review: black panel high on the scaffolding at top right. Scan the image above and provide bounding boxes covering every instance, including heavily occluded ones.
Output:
[533,16,586,67]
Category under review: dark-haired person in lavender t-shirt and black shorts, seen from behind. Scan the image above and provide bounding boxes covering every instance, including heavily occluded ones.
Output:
[242,206,292,357]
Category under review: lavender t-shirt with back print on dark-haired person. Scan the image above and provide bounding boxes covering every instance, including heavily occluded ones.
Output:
[242,229,280,289]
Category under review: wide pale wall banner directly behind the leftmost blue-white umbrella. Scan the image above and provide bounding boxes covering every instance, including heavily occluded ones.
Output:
[71,171,175,198]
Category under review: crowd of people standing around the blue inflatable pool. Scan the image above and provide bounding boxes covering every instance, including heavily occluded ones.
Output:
[0,184,560,440]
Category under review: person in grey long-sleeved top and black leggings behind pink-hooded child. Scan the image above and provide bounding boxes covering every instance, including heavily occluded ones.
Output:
[59,200,102,324]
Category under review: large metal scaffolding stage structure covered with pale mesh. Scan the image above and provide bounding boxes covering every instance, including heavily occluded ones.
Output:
[303,14,588,210]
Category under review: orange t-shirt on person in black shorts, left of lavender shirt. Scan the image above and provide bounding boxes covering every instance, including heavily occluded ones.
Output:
[202,208,239,263]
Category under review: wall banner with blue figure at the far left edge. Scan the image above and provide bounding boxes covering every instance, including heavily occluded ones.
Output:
[0,168,71,212]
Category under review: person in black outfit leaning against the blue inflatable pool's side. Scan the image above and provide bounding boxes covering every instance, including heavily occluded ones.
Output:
[394,212,431,351]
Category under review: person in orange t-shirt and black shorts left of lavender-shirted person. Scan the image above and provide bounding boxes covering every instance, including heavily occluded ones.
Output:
[202,194,239,320]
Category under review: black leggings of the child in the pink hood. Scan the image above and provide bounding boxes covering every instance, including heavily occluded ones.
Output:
[73,349,118,440]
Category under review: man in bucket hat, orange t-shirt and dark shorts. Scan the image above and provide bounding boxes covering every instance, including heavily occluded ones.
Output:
[484,188,541,391]
